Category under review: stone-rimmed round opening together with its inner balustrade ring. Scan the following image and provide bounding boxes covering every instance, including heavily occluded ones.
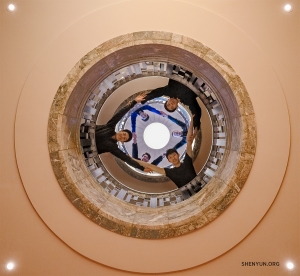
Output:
[48,31,256,238]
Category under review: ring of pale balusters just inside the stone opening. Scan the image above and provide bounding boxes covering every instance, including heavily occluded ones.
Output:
[80,61,227,208]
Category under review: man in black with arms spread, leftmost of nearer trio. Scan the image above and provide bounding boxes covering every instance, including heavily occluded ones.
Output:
[95,93,149,172]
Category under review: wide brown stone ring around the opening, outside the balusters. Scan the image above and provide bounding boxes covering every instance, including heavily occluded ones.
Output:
[48,29,256,239]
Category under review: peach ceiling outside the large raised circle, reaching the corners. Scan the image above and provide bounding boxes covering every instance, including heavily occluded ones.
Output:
[0,0,300,275]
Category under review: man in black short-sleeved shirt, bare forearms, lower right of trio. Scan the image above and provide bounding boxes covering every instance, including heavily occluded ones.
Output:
[136,116,197,188]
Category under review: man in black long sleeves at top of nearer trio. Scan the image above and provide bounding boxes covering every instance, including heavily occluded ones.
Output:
[142,79,201,131]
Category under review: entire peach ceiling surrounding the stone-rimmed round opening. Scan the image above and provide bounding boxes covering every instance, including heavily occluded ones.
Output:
[9,1,299,275]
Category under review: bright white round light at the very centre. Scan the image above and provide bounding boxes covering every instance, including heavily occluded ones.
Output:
[143,123,170,149]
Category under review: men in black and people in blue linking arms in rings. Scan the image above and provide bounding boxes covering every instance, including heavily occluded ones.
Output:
[95,79,201,188]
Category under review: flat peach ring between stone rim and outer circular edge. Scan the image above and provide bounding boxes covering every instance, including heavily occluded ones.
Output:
[15,1,290,273]
